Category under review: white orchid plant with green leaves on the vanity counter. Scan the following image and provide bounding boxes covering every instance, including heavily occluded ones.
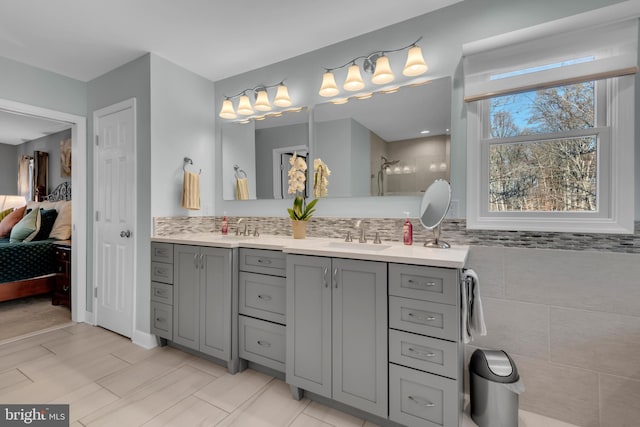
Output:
[287,153,331,221]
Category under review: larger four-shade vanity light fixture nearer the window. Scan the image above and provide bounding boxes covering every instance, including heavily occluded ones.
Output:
[319,37,429,97]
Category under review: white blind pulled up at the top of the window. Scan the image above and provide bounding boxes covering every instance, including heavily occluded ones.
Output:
[463,0,640,102]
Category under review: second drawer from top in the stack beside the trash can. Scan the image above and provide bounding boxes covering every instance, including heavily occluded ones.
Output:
[389,297,460,341]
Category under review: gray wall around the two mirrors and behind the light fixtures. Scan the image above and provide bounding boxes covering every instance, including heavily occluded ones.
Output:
[215,0,640,217]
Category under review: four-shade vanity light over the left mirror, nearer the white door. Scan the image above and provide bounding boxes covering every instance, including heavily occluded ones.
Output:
[220,80,291,119]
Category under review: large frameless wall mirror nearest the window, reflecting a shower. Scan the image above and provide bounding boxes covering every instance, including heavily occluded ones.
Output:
[313,77,451,197]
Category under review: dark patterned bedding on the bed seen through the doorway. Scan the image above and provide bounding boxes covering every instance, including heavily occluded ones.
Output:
[0,238,56,283]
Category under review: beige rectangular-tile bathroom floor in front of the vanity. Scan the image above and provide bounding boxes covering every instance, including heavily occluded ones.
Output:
[0,324,571,427]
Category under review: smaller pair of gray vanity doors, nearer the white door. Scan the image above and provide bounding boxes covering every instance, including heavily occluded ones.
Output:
[173,244,233,361]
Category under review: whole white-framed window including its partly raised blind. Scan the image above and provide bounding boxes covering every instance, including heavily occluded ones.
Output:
[463,12,638,233]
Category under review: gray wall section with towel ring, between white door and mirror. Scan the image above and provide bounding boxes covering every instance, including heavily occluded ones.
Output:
[151,54,216,217]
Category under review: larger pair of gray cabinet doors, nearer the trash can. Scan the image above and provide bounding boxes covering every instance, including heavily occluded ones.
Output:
[286,255,388,418]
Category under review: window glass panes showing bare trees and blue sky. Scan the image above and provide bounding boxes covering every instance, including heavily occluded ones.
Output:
[490,81,609,212]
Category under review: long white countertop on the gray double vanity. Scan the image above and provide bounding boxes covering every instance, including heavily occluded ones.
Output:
[151,233,469,268]
